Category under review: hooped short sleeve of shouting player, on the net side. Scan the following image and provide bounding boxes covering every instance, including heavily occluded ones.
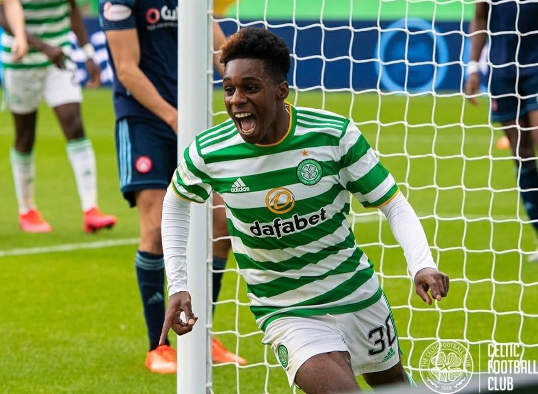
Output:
[339,122,398,208]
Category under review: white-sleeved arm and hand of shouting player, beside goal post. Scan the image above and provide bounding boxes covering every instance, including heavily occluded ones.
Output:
[160,186,198,344]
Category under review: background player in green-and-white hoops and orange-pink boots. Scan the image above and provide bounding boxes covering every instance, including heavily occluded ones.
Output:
[0,0,116,232]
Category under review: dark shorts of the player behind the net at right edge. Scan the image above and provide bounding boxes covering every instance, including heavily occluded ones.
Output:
[491,73,538,122]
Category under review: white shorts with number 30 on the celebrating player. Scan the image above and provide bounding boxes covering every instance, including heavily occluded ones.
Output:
[263,295,400,386]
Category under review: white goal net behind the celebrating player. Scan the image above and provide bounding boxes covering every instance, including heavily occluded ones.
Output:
[178,0,538,393]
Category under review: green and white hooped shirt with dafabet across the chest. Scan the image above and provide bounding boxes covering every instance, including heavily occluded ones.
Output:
[172,105,398,330]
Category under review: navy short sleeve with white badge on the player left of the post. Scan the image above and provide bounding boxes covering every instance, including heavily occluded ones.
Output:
[99,0,136,31]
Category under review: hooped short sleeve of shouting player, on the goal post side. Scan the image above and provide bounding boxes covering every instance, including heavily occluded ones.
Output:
[172,142,212,203]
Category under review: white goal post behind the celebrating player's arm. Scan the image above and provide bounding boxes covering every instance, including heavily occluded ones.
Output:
[177,0,213,394]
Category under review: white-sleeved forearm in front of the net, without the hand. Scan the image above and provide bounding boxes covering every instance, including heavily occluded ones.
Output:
[381,193,437,278]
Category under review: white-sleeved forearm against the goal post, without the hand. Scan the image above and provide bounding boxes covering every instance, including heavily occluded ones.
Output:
[161,186,190,296]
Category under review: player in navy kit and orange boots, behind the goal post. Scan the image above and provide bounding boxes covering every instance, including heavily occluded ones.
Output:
[99,0,245,373]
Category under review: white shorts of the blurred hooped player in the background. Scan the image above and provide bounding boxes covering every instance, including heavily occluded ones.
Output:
[3,61,82,115]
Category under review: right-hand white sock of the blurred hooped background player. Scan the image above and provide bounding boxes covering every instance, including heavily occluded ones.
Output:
[67,138,97,212]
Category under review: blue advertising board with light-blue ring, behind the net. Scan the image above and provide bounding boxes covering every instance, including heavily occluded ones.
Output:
[0,18,478,93]
